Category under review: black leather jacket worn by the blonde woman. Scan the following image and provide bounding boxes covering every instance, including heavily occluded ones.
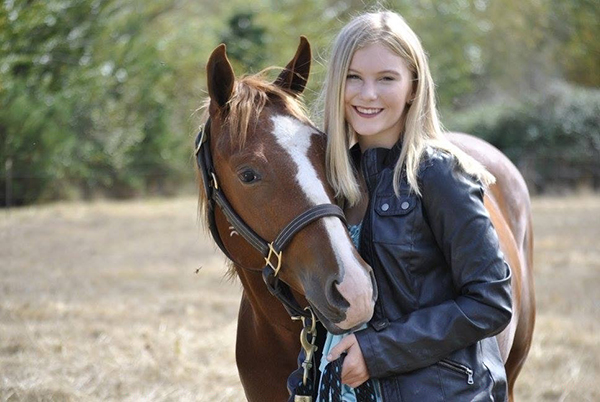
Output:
[288,143,512,402]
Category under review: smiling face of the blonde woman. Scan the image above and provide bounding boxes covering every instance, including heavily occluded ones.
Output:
[344,43,413,151]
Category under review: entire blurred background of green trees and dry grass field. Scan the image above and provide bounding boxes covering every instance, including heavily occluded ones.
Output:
[0,0,600,402]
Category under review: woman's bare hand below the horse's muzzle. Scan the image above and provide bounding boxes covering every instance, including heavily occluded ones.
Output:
[327,334,369,388]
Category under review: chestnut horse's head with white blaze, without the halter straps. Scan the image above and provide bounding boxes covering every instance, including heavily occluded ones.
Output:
[202,37,377,333]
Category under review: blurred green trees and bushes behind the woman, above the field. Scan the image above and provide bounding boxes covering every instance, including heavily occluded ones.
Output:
[0,0,600,205]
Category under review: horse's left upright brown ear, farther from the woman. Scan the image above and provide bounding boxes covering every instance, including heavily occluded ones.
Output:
[206,44,235,109]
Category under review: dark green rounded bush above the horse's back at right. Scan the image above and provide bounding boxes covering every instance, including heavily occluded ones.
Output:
[448,83,600,190]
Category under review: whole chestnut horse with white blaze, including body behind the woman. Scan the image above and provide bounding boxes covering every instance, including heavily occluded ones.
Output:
[199,37,535,402]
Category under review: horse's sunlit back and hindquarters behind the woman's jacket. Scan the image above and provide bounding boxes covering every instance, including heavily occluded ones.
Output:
[449,133,535,401]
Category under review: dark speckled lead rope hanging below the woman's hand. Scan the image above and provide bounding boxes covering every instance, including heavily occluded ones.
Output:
[317,353,377,402]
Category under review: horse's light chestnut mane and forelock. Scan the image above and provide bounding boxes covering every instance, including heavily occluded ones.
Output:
[196,70,314,279]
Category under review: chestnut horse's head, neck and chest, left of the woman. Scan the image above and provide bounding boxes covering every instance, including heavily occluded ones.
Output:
[197,37,377,401]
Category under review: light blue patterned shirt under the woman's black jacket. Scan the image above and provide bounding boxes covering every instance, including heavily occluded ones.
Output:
[317,222,382,402]
